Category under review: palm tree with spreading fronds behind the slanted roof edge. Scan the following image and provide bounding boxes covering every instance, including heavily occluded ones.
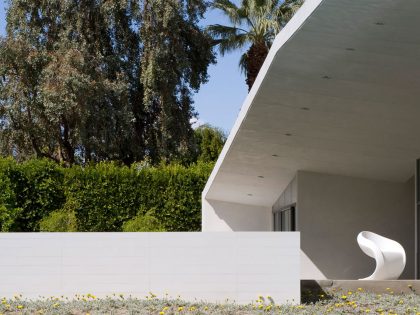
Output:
[207,0,303,90]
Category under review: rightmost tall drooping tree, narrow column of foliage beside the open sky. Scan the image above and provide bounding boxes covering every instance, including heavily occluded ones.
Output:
[141,0,214,160]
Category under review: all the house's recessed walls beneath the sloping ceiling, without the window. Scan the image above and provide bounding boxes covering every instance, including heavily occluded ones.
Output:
[202,171,415,280]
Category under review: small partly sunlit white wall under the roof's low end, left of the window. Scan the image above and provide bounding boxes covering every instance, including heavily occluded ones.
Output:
[202,198,273,232]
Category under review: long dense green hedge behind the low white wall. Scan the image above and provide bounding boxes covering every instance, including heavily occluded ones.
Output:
[0,159,213,231]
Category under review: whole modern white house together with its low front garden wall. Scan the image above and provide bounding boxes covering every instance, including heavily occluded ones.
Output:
[0,0,420,303]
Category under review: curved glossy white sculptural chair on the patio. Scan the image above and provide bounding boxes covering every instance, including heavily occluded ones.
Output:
[357,231,406,280]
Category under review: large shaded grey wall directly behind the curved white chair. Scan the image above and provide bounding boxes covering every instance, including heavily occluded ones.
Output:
[297,171,415,279]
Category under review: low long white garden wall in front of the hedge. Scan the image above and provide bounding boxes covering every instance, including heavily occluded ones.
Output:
[0,232,300,303]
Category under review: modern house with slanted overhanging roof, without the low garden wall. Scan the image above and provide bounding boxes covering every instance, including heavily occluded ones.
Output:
[202,0,420,279]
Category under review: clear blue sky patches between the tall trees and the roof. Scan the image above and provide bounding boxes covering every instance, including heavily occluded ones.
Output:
[0,0,247,132]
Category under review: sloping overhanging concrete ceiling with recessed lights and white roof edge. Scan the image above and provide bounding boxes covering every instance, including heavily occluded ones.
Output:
[203,0,420,206]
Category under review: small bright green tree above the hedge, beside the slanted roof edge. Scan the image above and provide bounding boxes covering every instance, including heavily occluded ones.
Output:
[194,125,226,162]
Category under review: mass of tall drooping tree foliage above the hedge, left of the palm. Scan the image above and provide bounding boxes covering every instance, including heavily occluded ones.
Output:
[0,0,214,165]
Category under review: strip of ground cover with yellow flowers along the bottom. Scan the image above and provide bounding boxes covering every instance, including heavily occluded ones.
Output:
[0,288,420,315]
